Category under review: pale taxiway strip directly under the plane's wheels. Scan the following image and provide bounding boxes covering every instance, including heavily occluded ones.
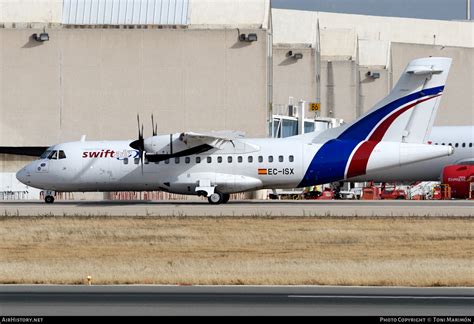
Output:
[0,200,474,216]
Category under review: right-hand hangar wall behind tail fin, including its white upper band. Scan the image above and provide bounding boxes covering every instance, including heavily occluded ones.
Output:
[272,9,474,125]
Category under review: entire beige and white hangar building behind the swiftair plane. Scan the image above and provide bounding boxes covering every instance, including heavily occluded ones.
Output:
[0,0,474,198]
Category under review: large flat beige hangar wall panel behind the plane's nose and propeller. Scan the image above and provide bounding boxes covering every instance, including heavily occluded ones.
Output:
[0,28,268,146]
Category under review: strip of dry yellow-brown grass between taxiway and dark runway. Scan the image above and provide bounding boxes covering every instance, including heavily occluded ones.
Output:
[0,217,474,286]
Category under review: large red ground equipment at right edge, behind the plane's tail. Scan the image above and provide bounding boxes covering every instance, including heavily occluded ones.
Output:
[442,165,474,199]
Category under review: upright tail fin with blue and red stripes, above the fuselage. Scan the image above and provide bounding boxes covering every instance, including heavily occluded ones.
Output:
[314,57,452,143]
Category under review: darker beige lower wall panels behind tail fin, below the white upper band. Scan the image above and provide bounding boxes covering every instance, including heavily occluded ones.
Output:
[273,43,474,126]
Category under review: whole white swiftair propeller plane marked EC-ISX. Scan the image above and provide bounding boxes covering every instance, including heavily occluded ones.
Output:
[17,57,454,204]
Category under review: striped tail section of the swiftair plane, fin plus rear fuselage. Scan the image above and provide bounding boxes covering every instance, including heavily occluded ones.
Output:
[299,57,452,187]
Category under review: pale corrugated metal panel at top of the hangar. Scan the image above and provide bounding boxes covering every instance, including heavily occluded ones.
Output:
[62,0,189,25]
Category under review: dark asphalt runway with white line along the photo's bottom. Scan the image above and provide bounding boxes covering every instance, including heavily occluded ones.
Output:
[0,285,474,316]
